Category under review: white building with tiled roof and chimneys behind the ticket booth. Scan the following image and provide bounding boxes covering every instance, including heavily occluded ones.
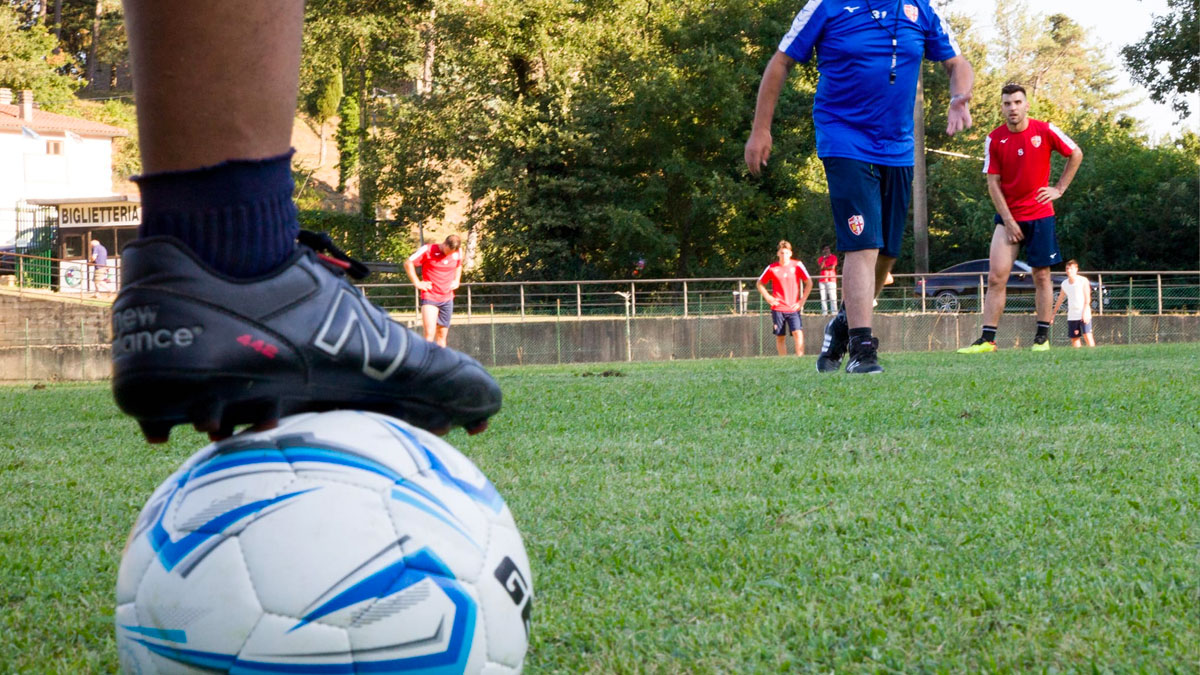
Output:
[0,89,126,247]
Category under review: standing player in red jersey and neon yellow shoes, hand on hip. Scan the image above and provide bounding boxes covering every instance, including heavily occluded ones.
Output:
[959,84,1084,354]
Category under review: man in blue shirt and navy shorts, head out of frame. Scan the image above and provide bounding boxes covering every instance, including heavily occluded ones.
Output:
[745,0,974,374]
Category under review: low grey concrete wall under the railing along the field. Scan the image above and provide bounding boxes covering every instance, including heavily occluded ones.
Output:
[0,293,1200,381]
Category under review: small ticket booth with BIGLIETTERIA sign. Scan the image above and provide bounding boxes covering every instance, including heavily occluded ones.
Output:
[29,195,142,293]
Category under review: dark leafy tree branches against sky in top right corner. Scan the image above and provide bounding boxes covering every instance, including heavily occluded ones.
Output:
[1121,0,1200,119]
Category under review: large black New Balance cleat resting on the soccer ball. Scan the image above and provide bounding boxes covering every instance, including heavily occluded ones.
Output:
[113,232,500,443]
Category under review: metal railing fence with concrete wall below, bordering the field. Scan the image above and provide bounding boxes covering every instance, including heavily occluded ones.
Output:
[0,262,1200,380]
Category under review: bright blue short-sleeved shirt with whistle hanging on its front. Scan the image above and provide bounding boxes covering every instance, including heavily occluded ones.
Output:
[779,0,960,167]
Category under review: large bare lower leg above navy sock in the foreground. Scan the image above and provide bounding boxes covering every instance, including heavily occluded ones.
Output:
[125,0,304,173]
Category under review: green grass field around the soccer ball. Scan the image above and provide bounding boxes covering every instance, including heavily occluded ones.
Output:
[0,345,1200,673]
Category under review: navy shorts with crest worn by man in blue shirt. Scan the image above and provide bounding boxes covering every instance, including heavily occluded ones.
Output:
[822,157,912,258]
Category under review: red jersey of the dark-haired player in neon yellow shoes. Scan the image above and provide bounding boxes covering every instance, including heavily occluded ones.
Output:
[983,118,1079,222]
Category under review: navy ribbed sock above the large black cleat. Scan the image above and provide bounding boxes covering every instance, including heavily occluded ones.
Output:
[133,151,300,279]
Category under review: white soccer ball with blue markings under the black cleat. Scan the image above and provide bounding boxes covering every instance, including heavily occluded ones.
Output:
[116,411,533,674]
